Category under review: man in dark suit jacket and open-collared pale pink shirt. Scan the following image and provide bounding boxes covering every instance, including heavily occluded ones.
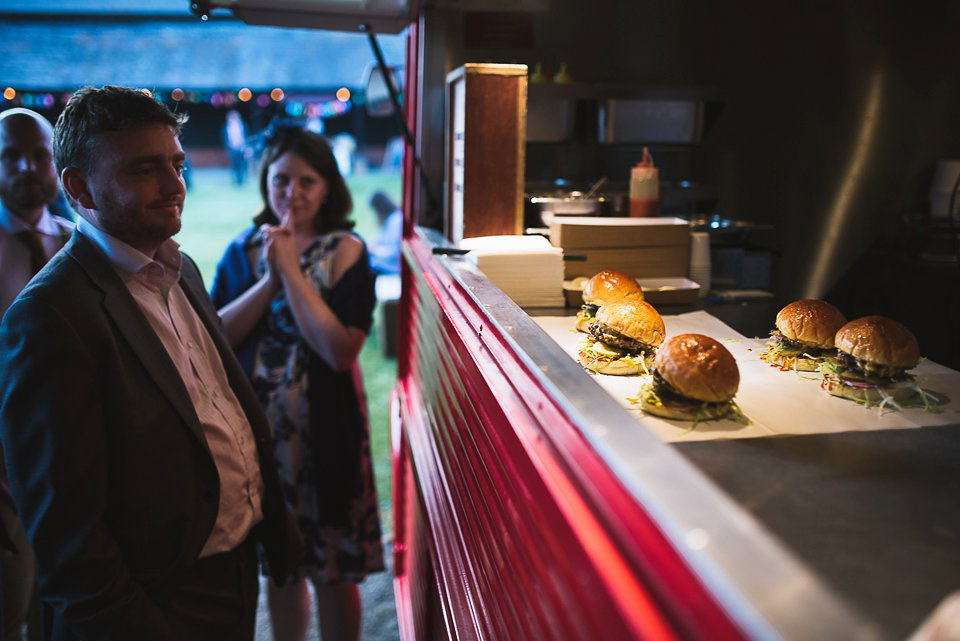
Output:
[0,87,292,641]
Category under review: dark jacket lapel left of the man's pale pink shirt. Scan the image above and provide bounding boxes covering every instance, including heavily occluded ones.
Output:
[65,232,209,451]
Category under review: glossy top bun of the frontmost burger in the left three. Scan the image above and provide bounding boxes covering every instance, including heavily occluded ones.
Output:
[654,334,740,403]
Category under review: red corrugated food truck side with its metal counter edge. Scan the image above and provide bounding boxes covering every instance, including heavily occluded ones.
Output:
[392,230,877,641]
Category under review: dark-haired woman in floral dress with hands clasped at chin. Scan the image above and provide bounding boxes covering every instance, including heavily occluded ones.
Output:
[212,127,384,641]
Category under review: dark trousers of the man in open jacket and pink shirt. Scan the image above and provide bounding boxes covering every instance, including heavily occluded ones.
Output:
[162,542,259,641]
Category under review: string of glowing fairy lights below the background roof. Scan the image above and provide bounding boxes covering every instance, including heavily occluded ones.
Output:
[0,87,363,118]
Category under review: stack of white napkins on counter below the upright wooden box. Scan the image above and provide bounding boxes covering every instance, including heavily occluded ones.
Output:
[460,236,563,307]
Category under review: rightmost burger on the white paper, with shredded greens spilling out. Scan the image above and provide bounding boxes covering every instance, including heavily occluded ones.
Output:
[820,316,922,405]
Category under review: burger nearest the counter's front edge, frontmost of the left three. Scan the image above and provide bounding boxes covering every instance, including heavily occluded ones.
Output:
[637,334,742,421]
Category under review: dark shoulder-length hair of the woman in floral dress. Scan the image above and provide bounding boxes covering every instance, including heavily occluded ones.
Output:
[253,125,354,234]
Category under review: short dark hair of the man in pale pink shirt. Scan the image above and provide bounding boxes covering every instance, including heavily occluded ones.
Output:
[53,85,187,173]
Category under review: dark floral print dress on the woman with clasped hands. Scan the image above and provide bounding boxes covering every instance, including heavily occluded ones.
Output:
[247,232,384,584]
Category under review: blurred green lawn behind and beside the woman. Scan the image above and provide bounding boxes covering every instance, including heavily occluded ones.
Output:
[175,169,400,531]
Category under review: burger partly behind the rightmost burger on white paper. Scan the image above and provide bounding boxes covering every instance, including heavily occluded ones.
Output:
[765,299,847,372]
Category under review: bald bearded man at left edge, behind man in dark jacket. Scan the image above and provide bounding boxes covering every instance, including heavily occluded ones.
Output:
[0,108,73,641]
